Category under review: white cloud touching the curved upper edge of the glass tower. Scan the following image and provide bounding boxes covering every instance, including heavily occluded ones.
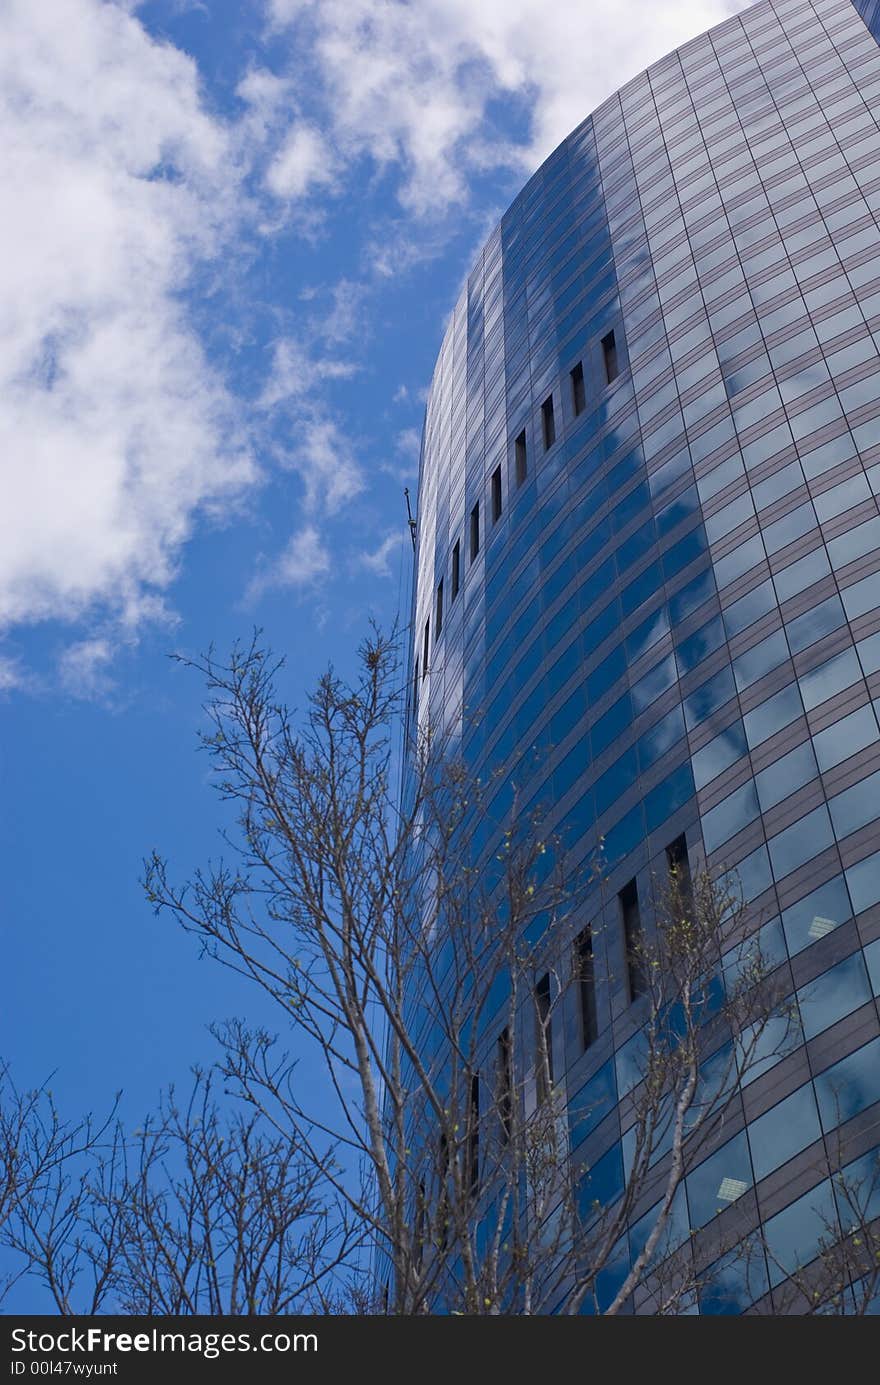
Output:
[269,0,748,213]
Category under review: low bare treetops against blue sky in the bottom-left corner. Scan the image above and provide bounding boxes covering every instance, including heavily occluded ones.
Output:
[0,1072,353,1316]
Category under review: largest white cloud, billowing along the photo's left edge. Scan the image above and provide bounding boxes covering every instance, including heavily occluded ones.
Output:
[0,0,256,625]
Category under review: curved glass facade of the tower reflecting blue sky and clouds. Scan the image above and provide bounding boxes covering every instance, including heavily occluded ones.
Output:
[409,0,880,1312]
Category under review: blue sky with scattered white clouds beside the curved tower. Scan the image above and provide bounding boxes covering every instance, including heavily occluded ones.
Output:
[0,0,743,1135]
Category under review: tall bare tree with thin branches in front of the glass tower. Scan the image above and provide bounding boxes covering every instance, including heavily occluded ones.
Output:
[146,632,831,1314]
